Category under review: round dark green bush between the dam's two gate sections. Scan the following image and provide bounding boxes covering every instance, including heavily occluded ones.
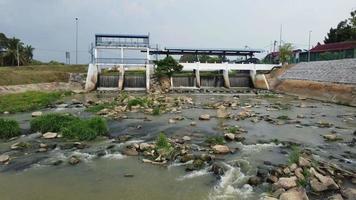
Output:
[155,56,183,77]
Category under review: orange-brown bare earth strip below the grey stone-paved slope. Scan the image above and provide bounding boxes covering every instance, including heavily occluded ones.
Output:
[266,65,356,106]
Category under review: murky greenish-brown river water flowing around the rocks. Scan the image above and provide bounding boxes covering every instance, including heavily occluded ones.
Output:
[0,95,356,200]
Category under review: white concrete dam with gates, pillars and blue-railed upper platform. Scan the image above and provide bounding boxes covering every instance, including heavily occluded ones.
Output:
[85,34,280,91]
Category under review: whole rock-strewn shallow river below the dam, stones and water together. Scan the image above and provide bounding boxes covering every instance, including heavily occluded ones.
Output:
[0,91,356,200]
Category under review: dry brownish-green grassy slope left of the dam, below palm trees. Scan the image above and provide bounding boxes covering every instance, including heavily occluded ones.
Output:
[0,65,87,86]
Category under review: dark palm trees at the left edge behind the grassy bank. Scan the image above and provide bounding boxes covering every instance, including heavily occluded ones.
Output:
[0,33,35,66]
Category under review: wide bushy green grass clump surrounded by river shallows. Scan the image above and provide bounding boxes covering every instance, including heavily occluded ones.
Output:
[30,113,108,141]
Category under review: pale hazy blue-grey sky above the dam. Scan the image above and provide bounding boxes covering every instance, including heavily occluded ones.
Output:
[0,0,356,63]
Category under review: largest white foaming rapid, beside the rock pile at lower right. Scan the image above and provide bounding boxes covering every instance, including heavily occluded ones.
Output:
[209,164,254,200]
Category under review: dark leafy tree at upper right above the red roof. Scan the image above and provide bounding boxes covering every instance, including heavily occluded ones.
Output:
[324,10,356,44]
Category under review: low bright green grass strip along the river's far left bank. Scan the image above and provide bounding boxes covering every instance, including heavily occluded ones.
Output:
[0,91,70,113]
